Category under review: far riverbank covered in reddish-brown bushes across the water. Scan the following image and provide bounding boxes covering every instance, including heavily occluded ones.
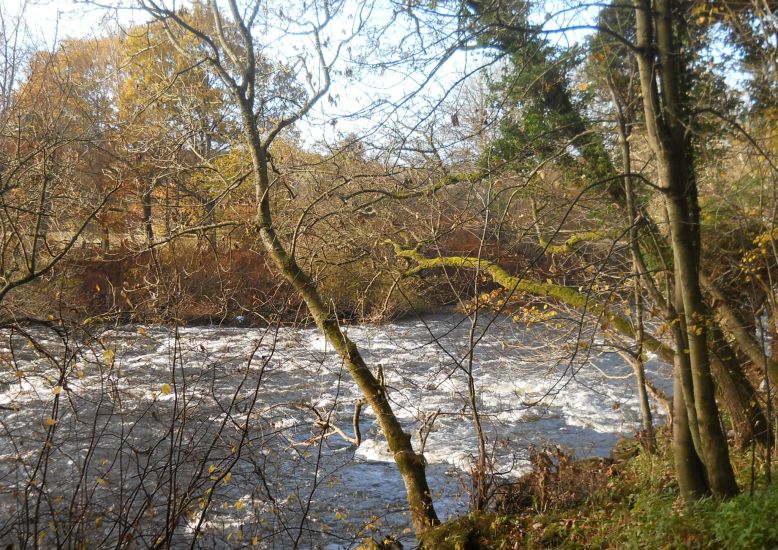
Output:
[3,243,472,327]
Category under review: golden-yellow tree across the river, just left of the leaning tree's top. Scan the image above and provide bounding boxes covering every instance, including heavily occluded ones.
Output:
[118,9,235,250]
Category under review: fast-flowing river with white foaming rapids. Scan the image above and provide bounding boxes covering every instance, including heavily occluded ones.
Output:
[0,314,670,548]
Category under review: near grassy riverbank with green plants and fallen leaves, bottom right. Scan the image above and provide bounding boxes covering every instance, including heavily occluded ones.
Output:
[420,434,778,550]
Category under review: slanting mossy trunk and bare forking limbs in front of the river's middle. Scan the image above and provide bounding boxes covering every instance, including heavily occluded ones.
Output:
[143,2,439,535]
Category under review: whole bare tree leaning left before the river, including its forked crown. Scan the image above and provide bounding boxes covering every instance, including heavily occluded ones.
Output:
[140,0,438,534]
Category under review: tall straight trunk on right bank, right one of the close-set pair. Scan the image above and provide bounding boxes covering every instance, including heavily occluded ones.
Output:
[634,0,738,498]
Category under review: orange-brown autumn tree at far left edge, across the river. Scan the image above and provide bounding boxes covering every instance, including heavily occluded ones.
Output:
[0,20,118,315]
